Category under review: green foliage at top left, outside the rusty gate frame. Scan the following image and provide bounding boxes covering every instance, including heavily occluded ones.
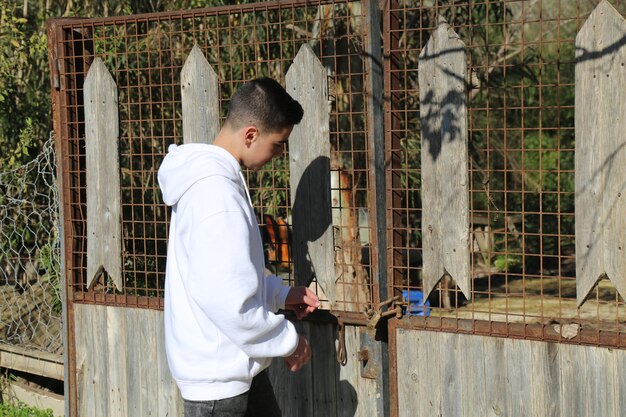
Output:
[0,0,256,171]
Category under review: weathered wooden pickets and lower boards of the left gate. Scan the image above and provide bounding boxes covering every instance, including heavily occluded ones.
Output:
[74,40,376,416]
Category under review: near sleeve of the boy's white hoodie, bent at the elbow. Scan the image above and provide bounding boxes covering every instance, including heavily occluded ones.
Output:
[187,211,298,358]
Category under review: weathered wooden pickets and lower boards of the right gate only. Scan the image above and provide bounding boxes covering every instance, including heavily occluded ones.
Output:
[390,1,626,417]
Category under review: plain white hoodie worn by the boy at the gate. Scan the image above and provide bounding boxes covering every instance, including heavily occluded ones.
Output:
[159,144,298,401]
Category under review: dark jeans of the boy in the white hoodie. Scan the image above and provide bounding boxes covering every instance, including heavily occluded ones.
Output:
[183,370,282,417]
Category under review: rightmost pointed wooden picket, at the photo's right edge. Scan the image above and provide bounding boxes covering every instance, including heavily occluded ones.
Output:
[575,0,626,306]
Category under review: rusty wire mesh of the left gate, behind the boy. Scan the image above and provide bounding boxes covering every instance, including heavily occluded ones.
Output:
[51,1,373,311]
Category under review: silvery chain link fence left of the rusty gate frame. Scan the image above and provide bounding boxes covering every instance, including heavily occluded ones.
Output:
[0,135,63,354]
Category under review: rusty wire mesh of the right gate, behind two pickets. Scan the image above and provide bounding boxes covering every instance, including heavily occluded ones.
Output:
[385,0,626,346]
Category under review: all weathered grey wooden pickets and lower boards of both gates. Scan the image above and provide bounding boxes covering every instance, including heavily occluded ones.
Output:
[50,1,626,417]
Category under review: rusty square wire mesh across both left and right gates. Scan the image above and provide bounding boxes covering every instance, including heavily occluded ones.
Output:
[48,0,626,347]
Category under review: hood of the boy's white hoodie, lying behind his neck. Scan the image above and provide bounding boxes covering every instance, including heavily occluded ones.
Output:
[158,143,241,206]
